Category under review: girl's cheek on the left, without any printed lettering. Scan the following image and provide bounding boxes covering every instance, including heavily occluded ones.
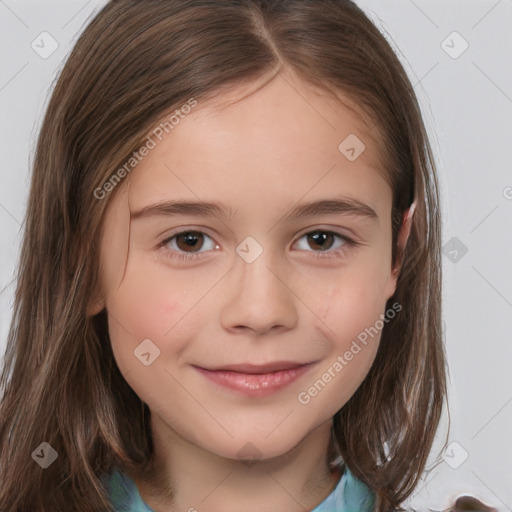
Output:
[107,266,204,411]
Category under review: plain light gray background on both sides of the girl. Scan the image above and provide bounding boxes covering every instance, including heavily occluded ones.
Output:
[0,0,512,511]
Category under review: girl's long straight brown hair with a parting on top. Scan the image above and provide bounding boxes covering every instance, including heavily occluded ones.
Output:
[0,0,446,512]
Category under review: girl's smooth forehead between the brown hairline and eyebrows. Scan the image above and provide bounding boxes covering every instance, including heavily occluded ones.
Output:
[123,69,387,216]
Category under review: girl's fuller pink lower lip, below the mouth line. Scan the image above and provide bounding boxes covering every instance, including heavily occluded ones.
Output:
[195,363,313,397]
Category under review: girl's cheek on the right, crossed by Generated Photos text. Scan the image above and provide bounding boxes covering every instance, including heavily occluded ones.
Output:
[301,257,389,406]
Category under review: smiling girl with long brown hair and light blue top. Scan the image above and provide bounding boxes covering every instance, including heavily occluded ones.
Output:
[0,0,496,512]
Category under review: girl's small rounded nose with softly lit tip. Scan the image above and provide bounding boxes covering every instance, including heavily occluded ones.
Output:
[220,250,298,335]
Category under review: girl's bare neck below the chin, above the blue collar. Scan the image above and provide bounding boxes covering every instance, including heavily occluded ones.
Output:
[133,416,341,512]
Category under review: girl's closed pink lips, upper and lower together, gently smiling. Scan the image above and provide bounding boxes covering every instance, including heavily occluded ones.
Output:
[194,361,315,397]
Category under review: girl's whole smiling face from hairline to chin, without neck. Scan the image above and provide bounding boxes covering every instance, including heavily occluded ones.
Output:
[98,71,397,464]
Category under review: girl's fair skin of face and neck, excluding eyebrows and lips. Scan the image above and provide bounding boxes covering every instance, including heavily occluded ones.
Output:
[92,68,414,512]
